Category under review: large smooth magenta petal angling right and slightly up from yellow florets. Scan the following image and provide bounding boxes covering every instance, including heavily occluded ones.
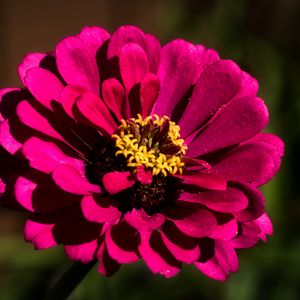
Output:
[187,97,268,157]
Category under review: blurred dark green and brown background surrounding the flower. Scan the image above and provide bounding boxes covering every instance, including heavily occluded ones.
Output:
[0,0,300,300]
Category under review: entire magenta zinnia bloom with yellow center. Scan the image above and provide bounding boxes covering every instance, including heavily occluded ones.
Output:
[0,26,283,280]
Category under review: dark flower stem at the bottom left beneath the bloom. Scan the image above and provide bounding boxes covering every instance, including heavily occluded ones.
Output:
[43,261,96,300]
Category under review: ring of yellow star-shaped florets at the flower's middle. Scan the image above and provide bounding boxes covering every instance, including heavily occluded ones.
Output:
[112,114,187,176]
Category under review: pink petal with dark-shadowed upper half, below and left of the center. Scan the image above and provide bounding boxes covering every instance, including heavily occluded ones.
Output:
[105,222,139,264]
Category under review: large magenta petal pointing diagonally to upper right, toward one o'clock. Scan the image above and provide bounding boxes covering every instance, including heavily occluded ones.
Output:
[179,60,242,137]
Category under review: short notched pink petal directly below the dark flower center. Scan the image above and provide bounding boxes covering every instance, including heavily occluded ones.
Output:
[124,208,165,232]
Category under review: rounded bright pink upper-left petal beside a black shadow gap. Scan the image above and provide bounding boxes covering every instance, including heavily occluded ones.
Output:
[24,68,63,109]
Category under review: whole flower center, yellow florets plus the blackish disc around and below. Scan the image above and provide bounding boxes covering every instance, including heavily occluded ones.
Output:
[86,116,187,215]
